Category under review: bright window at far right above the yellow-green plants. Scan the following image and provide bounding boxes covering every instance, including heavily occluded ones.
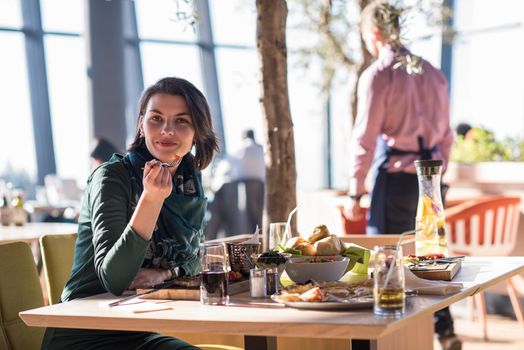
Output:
[451,0,524,138]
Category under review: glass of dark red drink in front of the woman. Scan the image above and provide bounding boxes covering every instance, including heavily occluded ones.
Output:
[199,243,229,305]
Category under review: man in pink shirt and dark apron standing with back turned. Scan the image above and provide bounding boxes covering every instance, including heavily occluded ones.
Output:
[346,2,461,349]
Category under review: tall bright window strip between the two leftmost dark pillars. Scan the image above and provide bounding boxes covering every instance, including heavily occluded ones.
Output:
[41,0,91,187]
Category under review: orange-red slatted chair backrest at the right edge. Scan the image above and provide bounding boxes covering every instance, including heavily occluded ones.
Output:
[445,196,520,256]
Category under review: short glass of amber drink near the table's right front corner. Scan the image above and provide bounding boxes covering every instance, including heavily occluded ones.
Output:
[373,245,406,316]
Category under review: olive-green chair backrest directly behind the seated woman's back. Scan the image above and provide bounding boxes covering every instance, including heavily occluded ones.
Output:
[40,233,77,305]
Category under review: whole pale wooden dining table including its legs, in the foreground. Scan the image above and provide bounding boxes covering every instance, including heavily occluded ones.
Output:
[20,257,524,350]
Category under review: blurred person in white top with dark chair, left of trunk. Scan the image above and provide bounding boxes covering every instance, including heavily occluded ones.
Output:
[204,129,266,239]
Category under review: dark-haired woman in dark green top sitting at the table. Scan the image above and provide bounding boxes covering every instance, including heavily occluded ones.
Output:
[43,78,218,349]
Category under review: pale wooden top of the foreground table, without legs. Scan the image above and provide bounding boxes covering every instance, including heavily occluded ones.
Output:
[20,257,524,339]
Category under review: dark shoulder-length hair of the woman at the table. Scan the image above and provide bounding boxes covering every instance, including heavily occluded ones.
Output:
[128,77,218,170]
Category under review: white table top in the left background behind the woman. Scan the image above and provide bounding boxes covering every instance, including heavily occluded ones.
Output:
[0,222,78,243]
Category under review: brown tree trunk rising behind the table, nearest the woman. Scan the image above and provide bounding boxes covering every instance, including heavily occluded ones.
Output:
[256,0,297,241]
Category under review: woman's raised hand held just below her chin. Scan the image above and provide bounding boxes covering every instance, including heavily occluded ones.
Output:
[142,159,173,199]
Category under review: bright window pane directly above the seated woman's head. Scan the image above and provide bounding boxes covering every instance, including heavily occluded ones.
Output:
[140,43,204,92]
